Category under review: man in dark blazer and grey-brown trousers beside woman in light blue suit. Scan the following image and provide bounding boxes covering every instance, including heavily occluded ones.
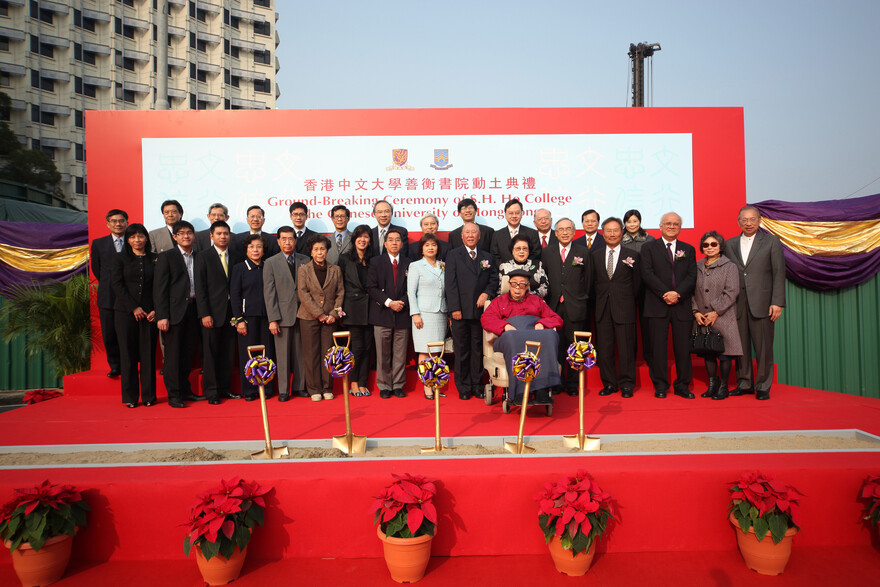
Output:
[367,227,412,399]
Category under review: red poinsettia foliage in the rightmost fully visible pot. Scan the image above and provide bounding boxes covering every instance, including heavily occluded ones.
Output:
[728,471,803,544]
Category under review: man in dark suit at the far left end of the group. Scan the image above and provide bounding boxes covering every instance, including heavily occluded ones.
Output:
[89,208,128,377]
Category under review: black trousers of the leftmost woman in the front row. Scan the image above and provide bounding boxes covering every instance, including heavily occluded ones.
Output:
[114,312,159,404]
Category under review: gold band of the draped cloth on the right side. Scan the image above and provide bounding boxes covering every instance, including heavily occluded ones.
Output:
[761,218,880,257]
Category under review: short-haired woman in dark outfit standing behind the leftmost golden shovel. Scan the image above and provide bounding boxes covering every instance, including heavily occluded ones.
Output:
[229,234,275,402]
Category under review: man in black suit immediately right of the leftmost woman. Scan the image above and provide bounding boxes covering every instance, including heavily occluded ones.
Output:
[153,220,207,408]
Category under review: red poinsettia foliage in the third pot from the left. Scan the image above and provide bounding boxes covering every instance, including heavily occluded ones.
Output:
[370,473,437,538]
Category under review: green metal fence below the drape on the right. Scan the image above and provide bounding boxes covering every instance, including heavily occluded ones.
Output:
[773,274,880,397]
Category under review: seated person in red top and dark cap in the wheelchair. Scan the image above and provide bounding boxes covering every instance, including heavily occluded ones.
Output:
[480,269,562,404]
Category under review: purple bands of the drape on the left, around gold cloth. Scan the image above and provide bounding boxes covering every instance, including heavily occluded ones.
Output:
[0,221,89,291]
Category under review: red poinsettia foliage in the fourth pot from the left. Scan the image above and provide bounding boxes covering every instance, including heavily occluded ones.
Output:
[535,469,614,556]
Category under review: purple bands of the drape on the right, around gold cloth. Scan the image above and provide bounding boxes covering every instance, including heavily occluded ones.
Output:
[752,194,880,291]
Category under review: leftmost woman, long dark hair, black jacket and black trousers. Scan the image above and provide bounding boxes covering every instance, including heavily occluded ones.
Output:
[110,223,159,408]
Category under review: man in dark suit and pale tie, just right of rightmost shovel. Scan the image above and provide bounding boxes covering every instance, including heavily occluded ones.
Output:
[588,218,642,398]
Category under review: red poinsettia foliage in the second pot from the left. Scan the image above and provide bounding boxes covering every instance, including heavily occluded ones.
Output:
[181,477,272,560]
